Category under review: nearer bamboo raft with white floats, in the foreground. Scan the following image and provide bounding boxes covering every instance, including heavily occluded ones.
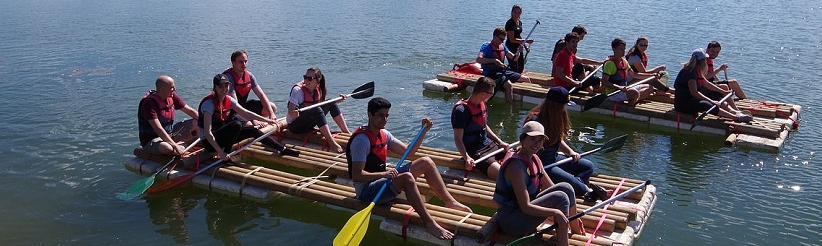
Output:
[125,126,656,245]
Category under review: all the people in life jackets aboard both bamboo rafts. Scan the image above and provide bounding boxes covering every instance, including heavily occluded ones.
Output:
[137,5,751,245]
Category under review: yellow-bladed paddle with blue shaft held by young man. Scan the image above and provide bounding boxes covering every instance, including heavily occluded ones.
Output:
[334,126,425,246]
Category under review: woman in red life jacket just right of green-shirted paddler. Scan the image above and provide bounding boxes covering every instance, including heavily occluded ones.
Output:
[625,36,674,95]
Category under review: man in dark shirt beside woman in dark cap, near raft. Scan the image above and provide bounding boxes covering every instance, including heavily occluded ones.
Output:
[451,76,508,179]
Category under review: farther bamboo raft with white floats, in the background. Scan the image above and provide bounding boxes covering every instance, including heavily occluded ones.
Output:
[423,70,802,151]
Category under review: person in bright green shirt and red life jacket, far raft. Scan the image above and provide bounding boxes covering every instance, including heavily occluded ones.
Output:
[601,38,659,106]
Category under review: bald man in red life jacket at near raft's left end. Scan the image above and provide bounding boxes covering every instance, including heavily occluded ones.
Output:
[137,75,199,155]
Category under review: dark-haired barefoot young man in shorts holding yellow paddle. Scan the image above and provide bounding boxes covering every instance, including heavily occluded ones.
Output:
[345,97,472,239]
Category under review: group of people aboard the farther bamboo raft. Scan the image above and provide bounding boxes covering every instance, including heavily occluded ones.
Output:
[476,5,753,125]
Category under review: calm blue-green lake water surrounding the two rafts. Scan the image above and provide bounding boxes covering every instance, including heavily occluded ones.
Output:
[0,0,822,245]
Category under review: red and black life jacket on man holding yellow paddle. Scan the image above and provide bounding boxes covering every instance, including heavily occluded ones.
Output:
[345,126,388,178]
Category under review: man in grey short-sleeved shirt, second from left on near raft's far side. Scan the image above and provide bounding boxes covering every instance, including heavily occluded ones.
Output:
[223,50,277,126]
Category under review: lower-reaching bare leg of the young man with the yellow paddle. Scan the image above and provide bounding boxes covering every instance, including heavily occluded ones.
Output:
[391,173,454,240]
